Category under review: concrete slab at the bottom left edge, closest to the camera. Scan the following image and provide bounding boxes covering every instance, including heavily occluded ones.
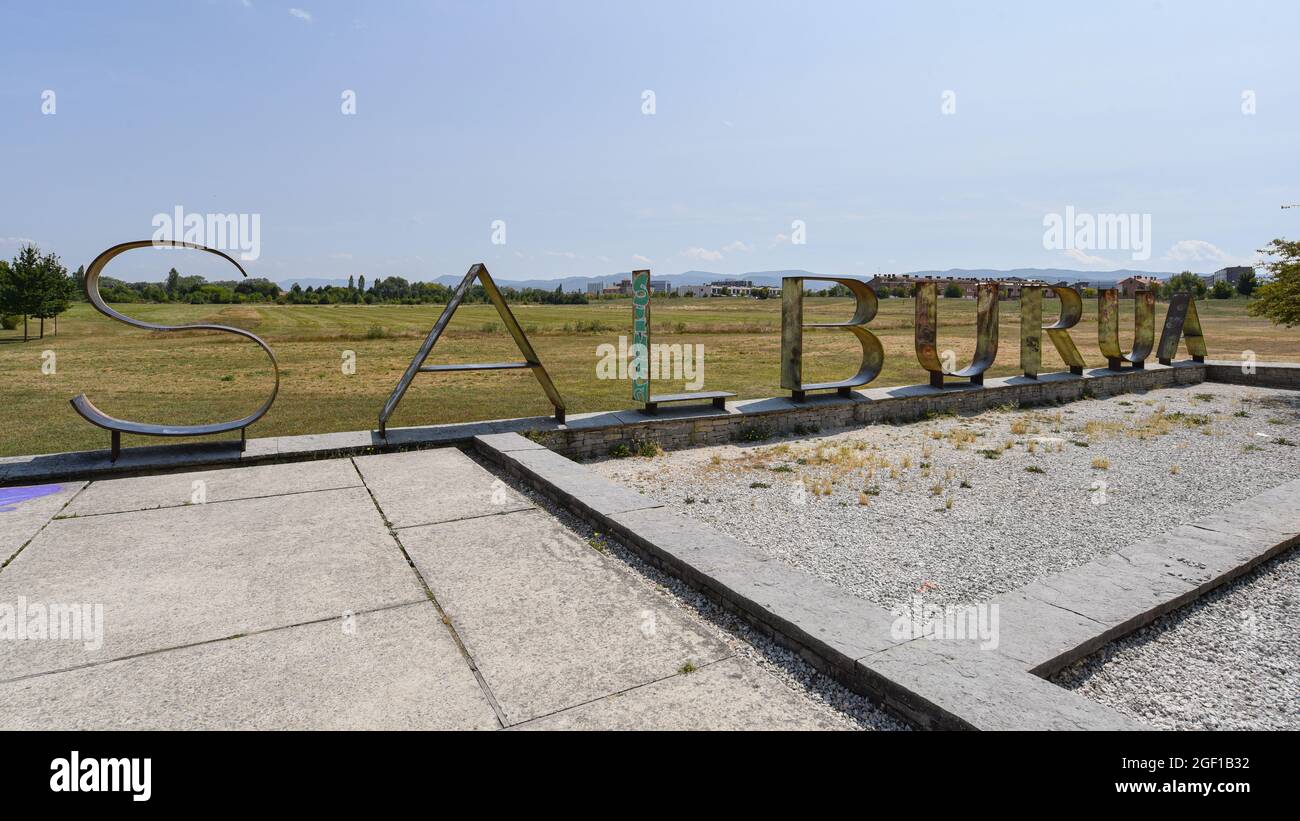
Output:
[0,601,499,730]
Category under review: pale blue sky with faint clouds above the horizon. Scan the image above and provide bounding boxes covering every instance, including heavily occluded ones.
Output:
[0,0,1300,279]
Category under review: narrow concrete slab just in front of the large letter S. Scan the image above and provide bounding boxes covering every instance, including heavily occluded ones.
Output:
[61,459,361,516]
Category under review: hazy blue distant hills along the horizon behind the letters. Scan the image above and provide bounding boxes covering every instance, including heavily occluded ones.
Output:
[280,268,1178,291]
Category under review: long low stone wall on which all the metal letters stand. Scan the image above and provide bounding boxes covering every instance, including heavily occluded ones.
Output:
[0,361,1206,487]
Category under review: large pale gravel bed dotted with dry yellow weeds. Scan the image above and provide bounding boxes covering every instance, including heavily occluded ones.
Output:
[589,383,1300,608]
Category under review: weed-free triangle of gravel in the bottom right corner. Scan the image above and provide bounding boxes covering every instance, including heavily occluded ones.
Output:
[1053,549,1300,730]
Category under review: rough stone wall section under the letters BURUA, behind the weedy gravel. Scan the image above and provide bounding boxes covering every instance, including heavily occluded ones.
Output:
[528,362,1205,460]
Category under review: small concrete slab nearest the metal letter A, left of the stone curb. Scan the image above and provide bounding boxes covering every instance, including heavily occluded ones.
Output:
[355,448,533,527]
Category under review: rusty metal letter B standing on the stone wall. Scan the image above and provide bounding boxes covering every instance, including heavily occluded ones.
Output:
[781,277,885,401]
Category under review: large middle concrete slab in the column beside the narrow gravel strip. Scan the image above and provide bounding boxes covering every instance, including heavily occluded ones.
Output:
[400,511,731,724]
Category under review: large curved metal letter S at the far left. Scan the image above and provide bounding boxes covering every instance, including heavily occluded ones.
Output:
[70,239,280,461]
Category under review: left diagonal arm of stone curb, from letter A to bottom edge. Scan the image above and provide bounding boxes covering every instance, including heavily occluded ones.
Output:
[475,434,1140,730]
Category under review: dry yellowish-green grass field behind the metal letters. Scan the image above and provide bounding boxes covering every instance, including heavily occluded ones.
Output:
[0,297,1300,456]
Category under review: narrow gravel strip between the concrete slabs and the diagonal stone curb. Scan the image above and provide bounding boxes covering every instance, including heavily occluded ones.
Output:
[469,452,910,730]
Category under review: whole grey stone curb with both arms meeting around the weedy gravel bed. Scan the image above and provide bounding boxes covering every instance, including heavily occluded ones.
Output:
[475,434,1300,730]
